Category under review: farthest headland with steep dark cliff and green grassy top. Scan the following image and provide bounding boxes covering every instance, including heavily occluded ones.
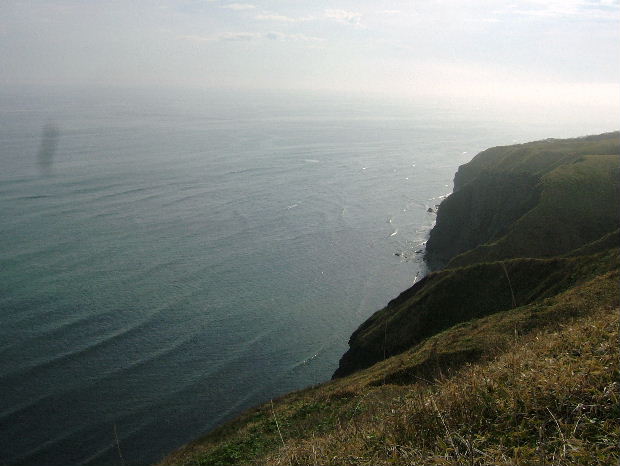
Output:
[425,132,620,270]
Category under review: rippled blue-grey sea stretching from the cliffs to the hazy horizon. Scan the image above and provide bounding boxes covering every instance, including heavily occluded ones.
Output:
[0,90,612,466]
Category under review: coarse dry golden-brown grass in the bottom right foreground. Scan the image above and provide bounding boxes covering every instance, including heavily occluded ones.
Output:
[266,308,620,465]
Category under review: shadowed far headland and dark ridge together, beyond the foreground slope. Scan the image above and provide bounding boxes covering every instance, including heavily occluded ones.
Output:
[334,133,620,377]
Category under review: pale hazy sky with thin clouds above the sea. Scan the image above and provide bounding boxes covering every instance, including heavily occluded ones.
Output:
[0,0,620,103]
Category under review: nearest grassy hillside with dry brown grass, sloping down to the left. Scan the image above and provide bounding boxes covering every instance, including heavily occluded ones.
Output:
[161,270,620,465]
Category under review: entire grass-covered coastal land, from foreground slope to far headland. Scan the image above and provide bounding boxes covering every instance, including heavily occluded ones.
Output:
[161,133,620,465]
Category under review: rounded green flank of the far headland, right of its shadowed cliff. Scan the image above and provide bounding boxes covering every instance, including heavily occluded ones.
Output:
[448,155,620,267]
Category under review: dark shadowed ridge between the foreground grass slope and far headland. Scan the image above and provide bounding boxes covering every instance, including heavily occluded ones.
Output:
[335,249,620,377]
